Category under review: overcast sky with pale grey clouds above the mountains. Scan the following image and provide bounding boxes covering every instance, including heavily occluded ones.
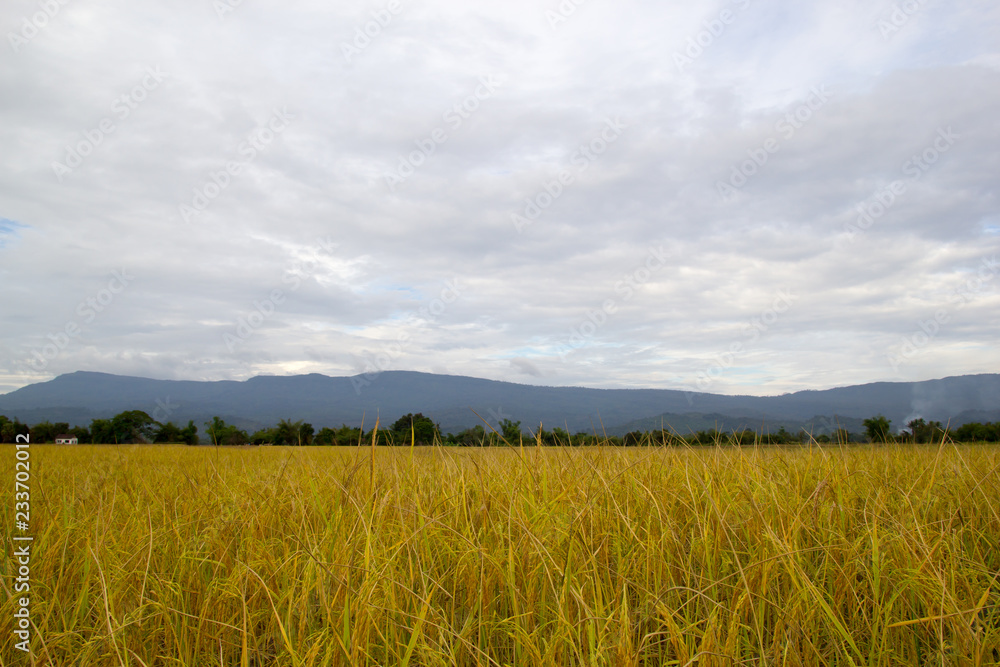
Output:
[0,0,1000,395]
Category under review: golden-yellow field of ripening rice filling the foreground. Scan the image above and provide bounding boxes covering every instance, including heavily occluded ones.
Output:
[0,443,1000,667]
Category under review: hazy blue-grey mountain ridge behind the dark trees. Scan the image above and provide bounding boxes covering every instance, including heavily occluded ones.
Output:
[0,371,1000,435]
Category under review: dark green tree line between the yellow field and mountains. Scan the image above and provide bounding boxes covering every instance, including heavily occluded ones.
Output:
[0,410,1000,447]
